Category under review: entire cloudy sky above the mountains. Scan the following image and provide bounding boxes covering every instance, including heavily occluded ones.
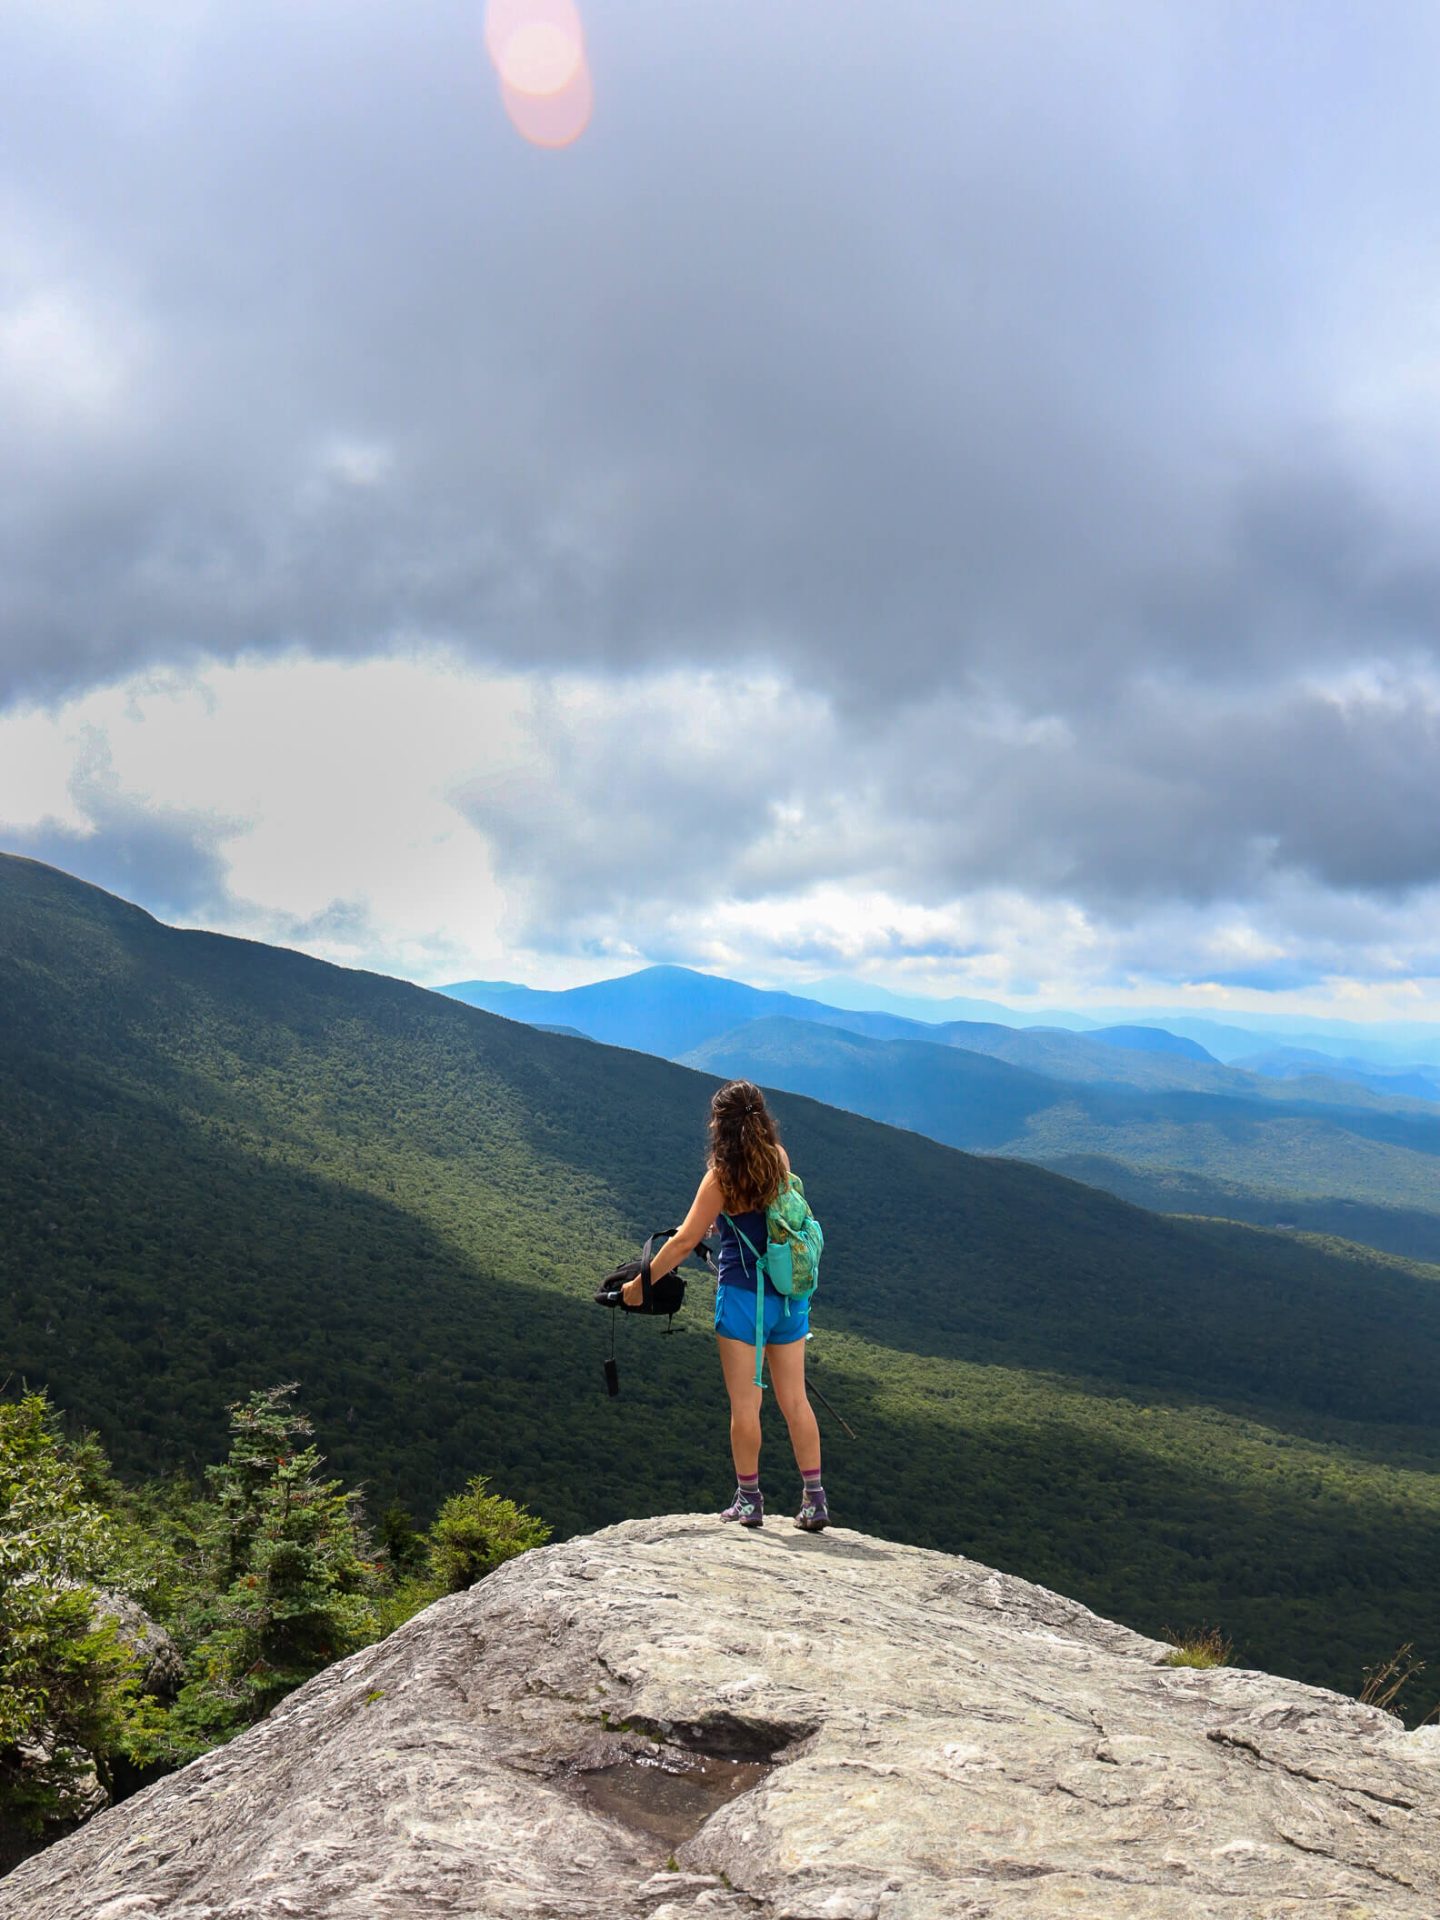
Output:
[0,0,1440,1020]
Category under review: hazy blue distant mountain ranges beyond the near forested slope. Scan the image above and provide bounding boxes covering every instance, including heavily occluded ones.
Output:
[445,966,1440,1261]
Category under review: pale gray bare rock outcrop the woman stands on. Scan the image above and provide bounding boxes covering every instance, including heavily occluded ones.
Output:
[0,1515,1440,1920]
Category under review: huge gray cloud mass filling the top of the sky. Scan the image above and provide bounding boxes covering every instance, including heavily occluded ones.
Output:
[0,0,1440,708]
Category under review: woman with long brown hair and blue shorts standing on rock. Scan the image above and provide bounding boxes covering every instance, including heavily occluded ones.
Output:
[624,1081,829,1534]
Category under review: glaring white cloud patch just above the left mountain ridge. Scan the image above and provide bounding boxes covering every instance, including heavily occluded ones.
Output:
[0,657,522,979]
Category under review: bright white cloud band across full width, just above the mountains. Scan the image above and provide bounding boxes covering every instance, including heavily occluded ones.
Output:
[0,651,1440,1018]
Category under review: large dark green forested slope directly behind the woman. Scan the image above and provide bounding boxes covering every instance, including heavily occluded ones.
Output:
[0,858,1440,1690]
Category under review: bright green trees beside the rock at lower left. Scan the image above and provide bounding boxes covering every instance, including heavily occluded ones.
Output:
[0,1384,549,1872]
